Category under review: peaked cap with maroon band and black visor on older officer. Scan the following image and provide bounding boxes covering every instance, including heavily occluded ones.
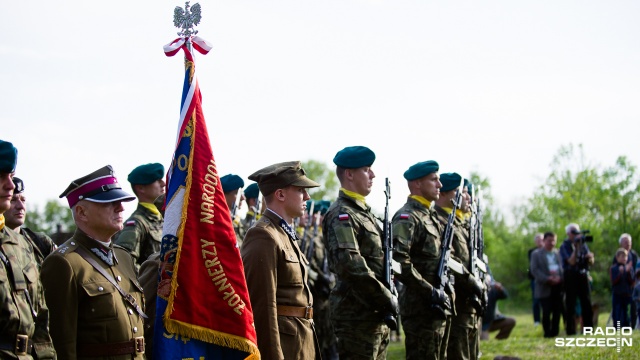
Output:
[60,165,136,207]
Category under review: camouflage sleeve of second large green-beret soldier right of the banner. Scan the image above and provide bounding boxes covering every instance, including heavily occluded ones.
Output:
[392,215,433,292]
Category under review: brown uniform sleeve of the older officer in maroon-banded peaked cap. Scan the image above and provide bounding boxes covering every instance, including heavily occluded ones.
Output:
[40,253,78,359]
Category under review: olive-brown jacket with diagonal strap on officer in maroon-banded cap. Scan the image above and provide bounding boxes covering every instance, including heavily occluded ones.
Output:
[42,229,144,360]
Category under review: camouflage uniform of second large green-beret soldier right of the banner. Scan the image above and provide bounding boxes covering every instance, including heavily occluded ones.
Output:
[392,197,451,359]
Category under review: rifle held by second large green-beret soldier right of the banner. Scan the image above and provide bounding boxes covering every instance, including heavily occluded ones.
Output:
[431,179,464,319]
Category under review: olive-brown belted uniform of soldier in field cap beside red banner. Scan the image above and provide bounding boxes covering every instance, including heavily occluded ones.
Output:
[240,209,316,360]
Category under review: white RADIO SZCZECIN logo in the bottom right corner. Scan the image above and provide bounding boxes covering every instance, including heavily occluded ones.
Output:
[555,323,633,352]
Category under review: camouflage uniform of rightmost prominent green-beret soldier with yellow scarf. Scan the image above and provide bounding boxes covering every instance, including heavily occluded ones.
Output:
[435,205,478,360]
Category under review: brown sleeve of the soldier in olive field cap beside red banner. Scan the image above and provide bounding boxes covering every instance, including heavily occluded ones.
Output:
[241,225,284,359]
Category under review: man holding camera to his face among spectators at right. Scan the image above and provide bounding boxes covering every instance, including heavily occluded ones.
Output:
[560,224,594,335]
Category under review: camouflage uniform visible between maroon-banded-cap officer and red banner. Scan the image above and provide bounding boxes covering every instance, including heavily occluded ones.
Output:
[113,204,164,271]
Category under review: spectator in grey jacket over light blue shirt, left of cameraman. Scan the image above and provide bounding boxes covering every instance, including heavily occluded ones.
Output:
[531,232,563,338]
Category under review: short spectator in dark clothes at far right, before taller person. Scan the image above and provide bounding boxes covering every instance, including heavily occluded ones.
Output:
[610,248,633,327]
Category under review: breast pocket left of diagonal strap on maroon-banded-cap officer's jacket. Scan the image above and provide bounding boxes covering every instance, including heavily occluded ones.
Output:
[78,280,119,320]
